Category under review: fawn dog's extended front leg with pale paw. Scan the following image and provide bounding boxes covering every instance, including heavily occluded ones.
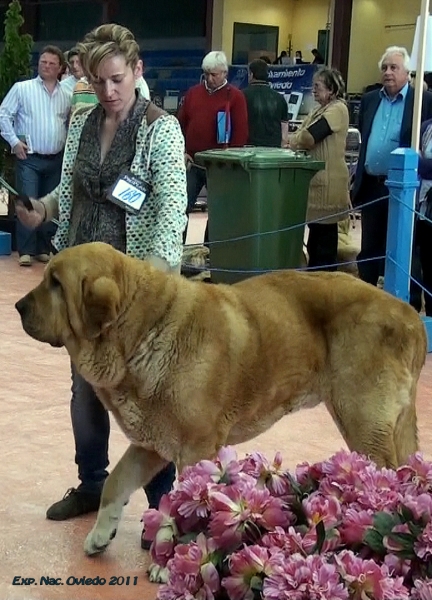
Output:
[84,445,168,555]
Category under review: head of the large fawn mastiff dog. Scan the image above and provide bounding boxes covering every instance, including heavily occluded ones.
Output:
[15,242,125,347]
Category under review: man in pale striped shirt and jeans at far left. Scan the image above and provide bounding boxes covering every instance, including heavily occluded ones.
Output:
[0,46,71,266]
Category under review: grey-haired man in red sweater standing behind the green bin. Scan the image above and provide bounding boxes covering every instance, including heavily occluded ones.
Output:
[178,51,248,241]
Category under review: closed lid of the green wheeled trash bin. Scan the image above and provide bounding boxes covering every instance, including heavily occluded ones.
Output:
[195,146,325,171]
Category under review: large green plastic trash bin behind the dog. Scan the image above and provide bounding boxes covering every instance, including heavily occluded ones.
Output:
[195,147,325,283]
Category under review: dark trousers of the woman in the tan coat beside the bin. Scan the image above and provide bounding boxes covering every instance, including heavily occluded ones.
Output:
[307,223,338,271]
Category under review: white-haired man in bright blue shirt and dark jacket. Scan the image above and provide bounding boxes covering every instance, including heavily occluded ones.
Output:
[353,46,432,285]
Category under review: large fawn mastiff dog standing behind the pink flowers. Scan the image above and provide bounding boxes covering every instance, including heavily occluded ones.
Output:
[16,243,426,554]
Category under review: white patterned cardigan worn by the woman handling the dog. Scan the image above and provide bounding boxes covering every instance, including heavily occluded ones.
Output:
[42,108,187,268]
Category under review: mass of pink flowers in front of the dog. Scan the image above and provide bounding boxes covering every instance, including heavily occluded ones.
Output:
[143,448,432,600]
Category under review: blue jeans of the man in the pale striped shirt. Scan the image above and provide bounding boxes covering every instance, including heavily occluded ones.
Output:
[15,152,63,256]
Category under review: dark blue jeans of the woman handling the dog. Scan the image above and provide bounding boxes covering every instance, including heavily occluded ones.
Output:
[71,365,176,508]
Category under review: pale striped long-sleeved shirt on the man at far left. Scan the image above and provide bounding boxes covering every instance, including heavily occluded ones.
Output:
[0,75,71,154]
